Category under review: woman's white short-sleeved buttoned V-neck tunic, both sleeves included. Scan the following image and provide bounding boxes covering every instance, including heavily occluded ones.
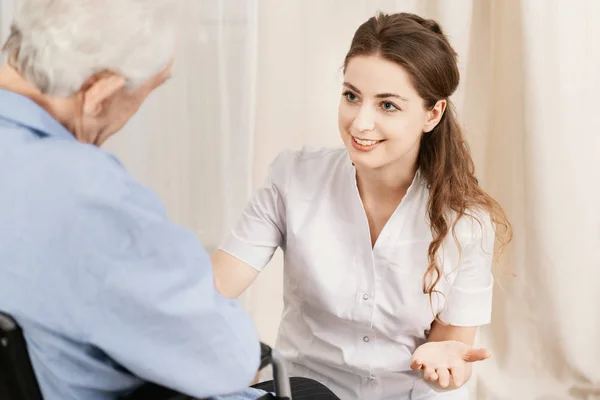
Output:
[221,149,494,400]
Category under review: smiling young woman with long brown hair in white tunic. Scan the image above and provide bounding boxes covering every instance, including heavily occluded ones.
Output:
[213,13,510,400]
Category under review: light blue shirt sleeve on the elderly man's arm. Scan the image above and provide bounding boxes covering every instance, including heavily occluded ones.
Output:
[69,155,260,398]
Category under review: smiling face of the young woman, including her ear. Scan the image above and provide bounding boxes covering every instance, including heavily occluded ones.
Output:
[338,56,445,169]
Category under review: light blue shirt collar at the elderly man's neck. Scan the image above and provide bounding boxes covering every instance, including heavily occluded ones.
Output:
[0,89,75,140]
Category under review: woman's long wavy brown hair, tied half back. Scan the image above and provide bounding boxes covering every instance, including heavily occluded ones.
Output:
[344,13,512,298]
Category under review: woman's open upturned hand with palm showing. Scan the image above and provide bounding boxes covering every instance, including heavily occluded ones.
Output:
[410,340,491,389]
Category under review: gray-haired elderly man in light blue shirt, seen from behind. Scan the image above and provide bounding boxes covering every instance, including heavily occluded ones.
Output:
[0,0,260,400]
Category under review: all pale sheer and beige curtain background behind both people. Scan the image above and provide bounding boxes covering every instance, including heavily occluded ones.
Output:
[0,0,600,400]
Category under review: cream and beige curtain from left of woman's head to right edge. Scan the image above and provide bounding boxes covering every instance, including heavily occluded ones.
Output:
[248,0,600,400]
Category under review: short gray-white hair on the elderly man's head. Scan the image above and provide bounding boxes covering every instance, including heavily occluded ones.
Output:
[4,0,180,96]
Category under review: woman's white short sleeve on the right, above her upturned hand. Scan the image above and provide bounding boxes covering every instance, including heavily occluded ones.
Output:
[439,214,495,326]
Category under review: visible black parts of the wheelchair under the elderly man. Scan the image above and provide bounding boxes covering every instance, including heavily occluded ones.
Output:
[0,312,292,400]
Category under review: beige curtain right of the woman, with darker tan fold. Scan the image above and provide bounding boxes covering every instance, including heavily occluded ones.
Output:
[476,0,600,400]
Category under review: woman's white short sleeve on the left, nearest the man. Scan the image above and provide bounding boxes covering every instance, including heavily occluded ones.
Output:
[219,150,296,271]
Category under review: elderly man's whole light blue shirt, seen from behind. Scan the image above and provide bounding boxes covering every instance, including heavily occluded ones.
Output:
[0,90,259,400]
